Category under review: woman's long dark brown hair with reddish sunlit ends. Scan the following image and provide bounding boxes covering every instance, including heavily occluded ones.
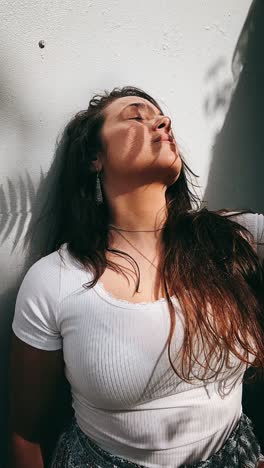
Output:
[25,86,264,392]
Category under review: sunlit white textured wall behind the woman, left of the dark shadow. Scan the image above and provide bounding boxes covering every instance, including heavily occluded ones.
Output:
[0,0,256,460]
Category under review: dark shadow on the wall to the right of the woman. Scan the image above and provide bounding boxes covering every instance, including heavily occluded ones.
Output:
[204,0,264,452]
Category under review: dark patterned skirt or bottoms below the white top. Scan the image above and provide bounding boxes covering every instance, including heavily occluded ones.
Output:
[50,413,262,468]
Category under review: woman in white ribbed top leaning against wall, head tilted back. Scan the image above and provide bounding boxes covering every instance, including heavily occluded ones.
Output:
[7,87,264,468]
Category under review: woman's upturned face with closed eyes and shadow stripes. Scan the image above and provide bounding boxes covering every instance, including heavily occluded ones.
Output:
[98,96,182,187]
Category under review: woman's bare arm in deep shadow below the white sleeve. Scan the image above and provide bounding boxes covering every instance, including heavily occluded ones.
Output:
[8,333,69,468]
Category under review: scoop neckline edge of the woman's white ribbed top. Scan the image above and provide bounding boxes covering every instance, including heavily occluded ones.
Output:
[93,280,176,309]
